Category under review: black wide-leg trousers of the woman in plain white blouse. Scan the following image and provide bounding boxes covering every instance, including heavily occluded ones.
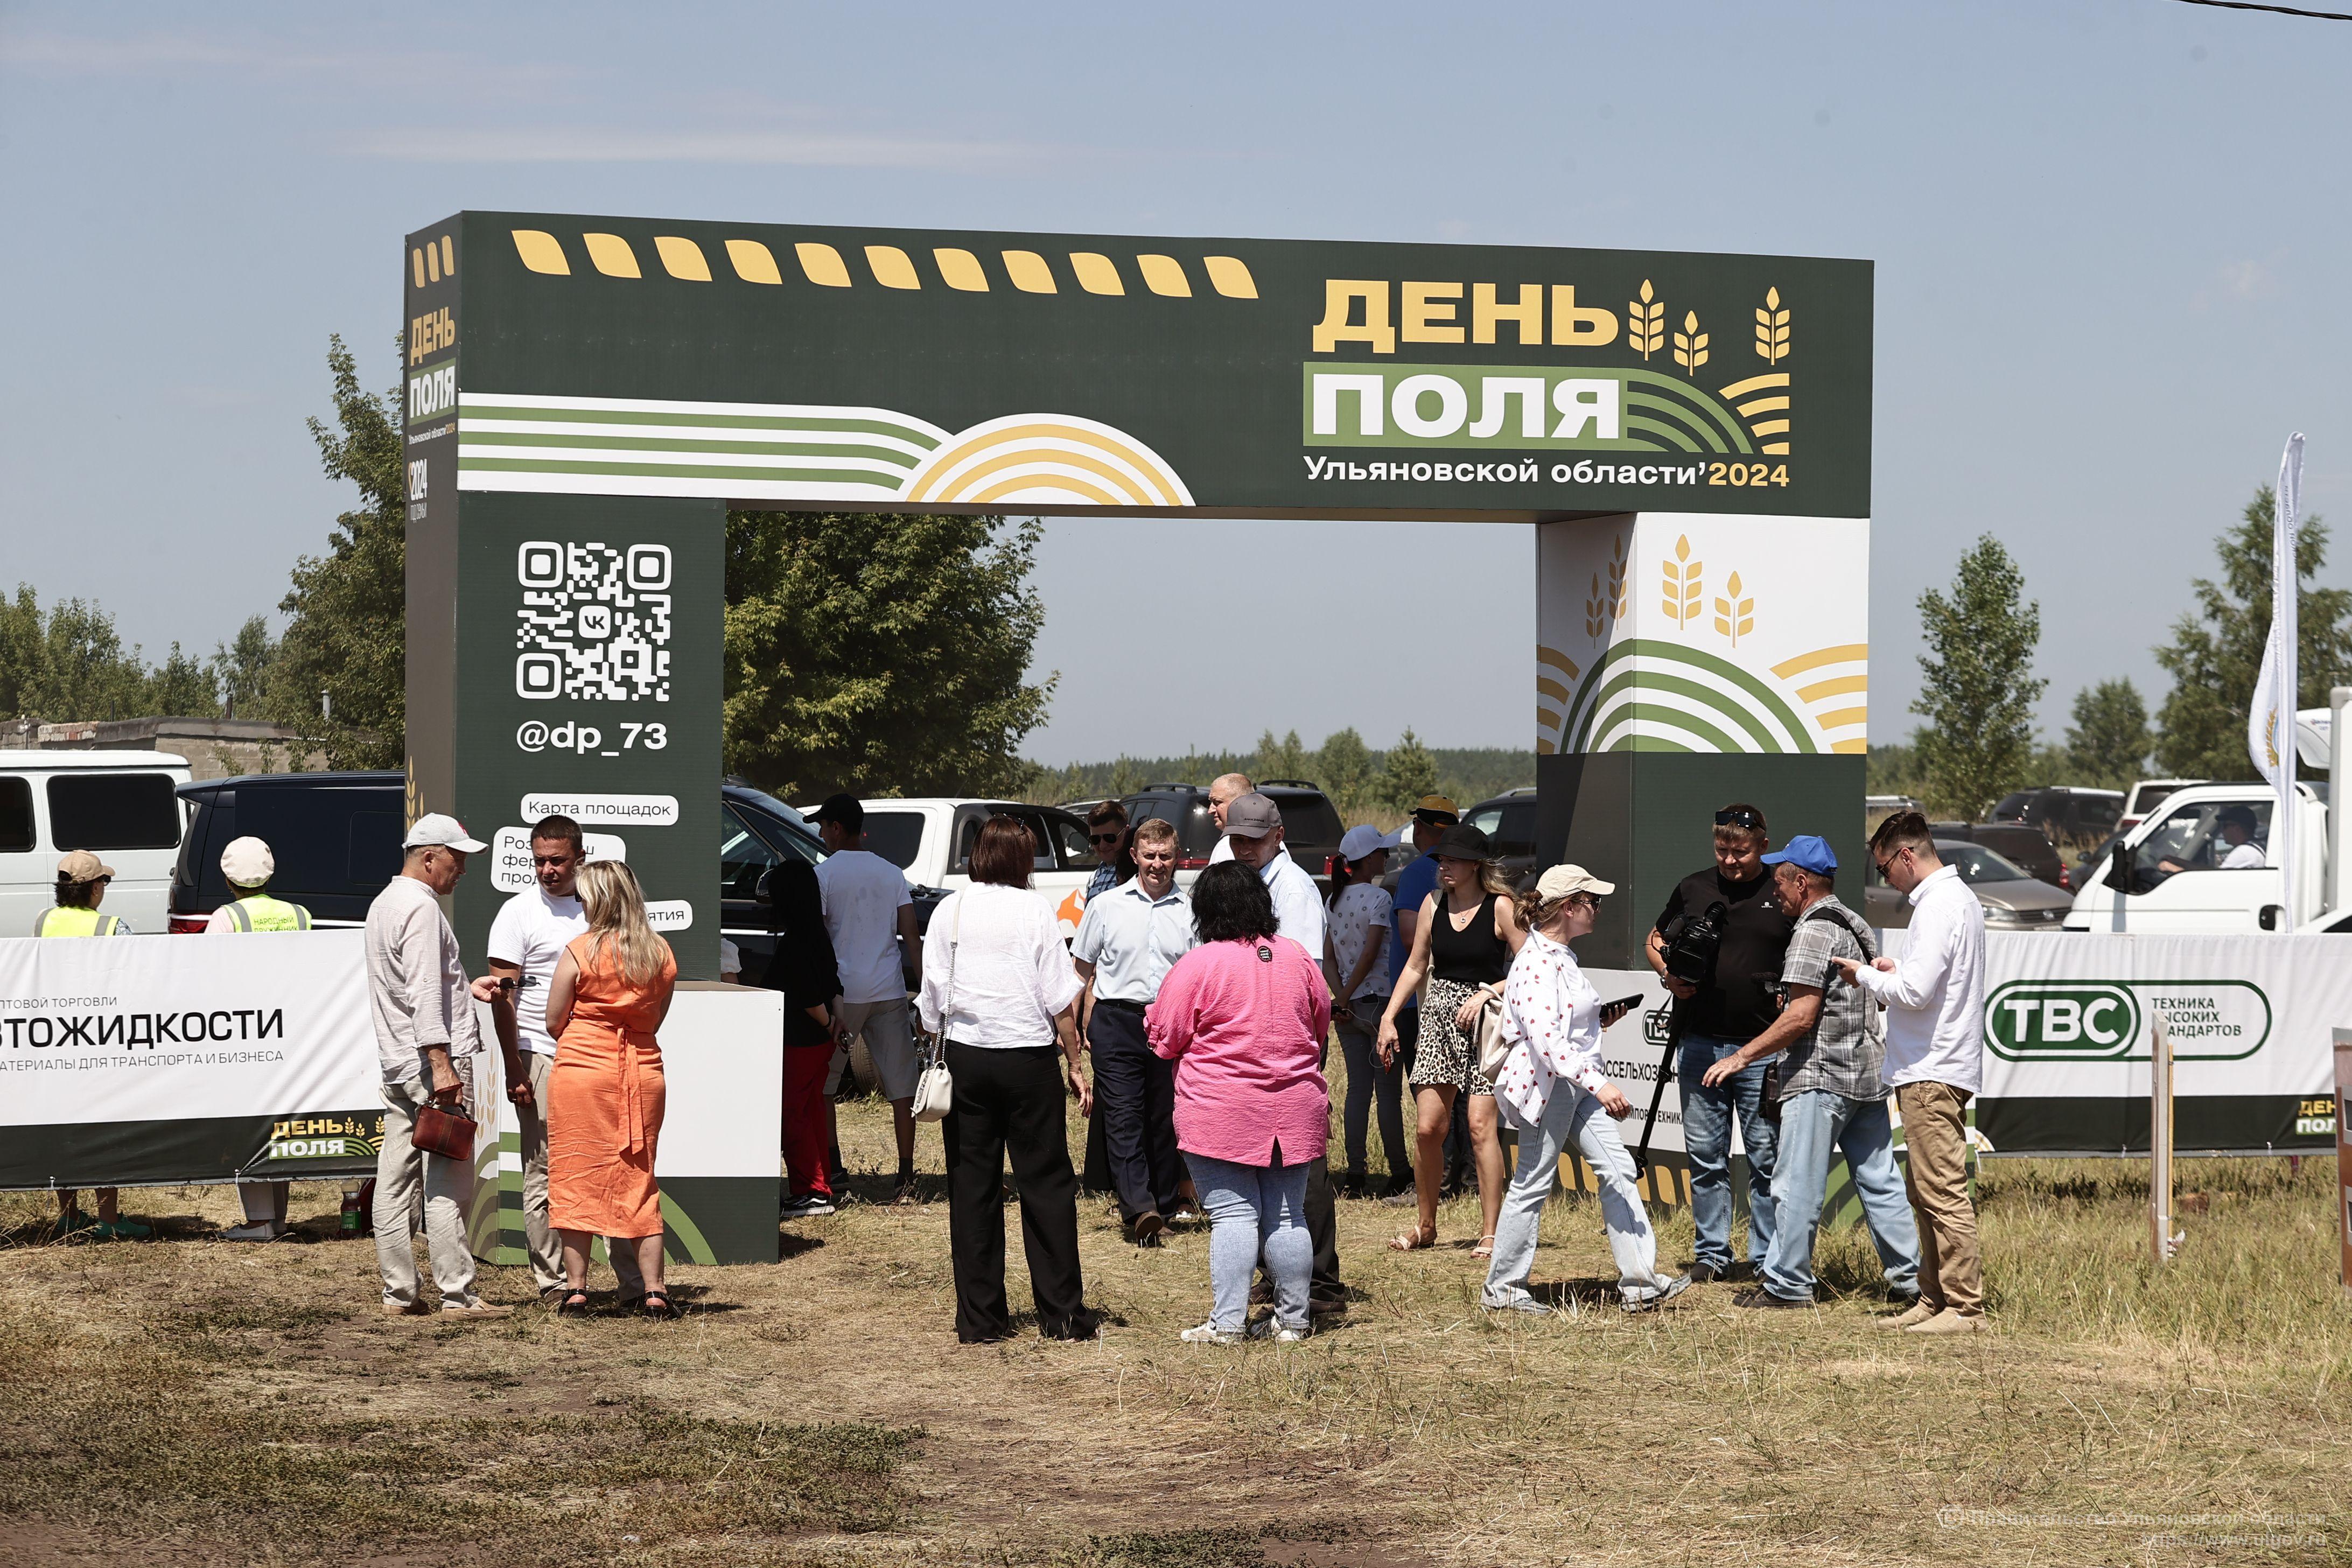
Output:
[941,1039,1094,1345]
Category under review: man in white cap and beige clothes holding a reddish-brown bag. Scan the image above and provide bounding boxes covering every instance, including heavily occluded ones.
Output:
[367,811,513,1324]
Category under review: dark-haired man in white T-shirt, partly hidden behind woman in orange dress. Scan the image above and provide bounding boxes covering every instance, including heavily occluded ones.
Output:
[487,816,645,1303]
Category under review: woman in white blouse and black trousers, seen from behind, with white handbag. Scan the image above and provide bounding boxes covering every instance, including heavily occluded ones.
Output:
[915,816,1098,1345]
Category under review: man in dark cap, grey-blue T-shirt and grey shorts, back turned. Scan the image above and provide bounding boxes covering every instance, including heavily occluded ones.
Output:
[809,795,922,1203]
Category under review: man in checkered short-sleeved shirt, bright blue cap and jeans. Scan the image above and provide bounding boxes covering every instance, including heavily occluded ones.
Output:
[1705,835,1919,1307]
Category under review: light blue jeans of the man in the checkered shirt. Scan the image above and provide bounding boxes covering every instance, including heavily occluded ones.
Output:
[1762,1088,1919,1303]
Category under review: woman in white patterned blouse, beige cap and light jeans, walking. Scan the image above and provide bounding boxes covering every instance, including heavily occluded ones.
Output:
[1479,865,1691,1312]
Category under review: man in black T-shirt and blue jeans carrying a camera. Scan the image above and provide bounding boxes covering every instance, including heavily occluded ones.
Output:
[1644,804,1790,1281]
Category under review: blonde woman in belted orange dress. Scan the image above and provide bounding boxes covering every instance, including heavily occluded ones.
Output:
[545,860,677,1319]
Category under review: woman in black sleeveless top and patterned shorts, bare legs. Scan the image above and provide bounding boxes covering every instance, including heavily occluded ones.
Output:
[1381,823,1527,1258]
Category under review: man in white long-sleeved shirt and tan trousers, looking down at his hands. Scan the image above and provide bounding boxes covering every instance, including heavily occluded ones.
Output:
[1835,811,1985,1333]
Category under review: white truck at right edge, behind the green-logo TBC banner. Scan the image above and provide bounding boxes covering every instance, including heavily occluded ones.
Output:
[2065,687,2352,933]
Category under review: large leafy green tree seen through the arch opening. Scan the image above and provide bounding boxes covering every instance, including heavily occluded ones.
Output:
[724,513,1059,799]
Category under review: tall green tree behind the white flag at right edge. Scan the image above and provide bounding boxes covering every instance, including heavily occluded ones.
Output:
[2157,484,2352,778]
